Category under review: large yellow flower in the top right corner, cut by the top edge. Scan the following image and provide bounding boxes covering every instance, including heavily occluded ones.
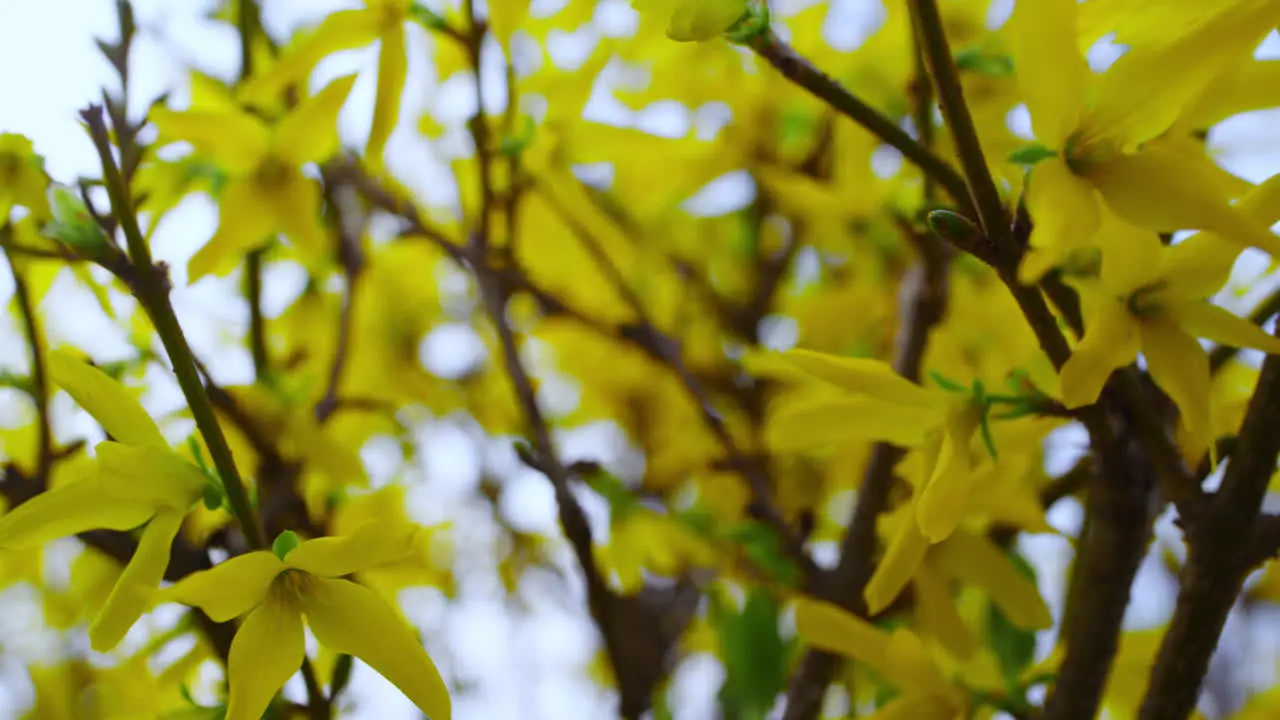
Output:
[1009,0,1280,282]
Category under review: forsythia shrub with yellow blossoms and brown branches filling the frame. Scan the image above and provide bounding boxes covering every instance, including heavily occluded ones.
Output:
[0,0,1280,720]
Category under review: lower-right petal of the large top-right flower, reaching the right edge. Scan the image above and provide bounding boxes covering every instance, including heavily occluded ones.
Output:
[1085,147,1280,256]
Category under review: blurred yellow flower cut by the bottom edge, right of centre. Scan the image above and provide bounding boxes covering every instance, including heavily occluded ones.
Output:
[795,598,969,720]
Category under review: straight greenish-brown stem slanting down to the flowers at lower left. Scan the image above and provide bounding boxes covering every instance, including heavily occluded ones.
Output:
[82,105,266,550]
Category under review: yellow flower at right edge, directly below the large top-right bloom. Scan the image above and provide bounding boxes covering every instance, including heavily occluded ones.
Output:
[1062,204,1280,450]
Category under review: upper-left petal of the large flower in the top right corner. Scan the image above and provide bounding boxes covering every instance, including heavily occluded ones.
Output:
[1009,0,1089,150]
